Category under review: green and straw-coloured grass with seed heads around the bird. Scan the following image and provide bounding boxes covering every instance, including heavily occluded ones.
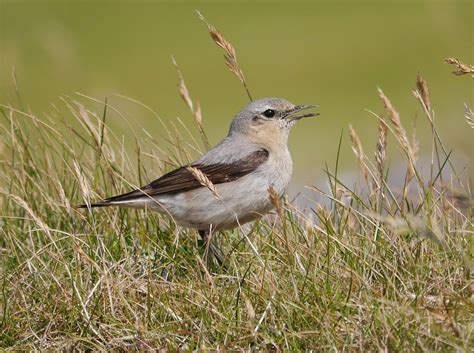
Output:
[0,22,474,351]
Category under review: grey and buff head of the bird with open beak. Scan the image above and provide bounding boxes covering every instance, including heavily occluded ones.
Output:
[229,98,319,143]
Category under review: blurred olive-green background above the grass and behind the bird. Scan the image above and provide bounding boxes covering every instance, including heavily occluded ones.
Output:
[0,0,474,183]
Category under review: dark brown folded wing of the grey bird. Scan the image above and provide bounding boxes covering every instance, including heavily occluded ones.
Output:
[97,149,269,206]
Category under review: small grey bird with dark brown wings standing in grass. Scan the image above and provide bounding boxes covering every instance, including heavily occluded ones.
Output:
[79,98,319,264]
